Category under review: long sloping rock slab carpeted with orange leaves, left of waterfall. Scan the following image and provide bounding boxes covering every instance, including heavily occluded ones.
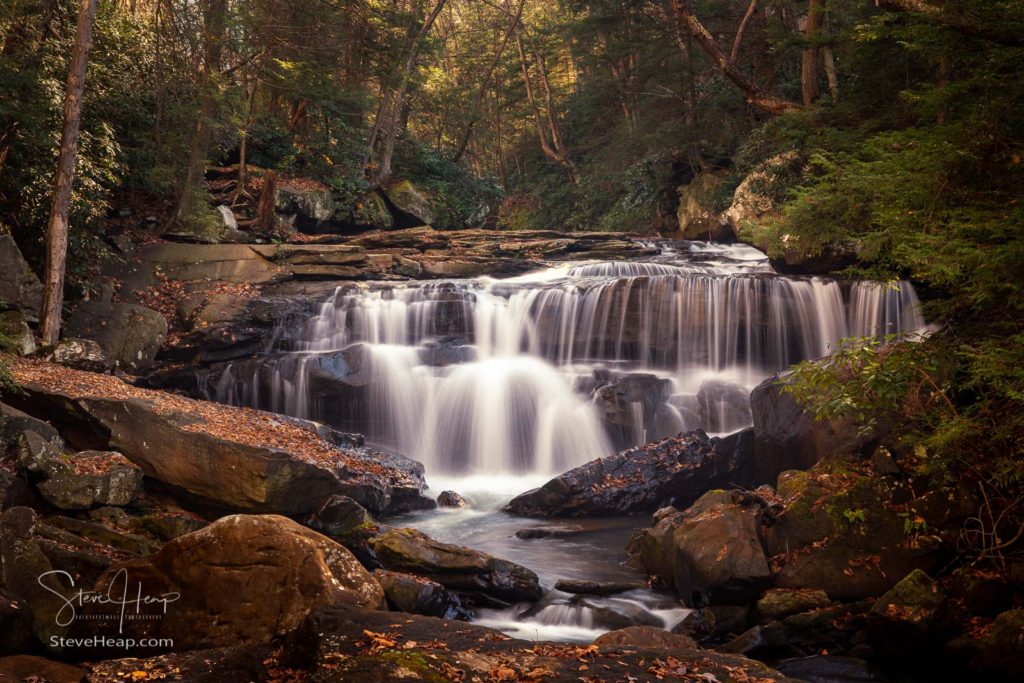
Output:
[4,360,434,516]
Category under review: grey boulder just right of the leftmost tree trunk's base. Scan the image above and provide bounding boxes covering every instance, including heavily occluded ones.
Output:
[66,301,167,374]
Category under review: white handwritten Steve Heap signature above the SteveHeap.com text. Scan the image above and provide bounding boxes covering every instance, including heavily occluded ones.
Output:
[37,568,181,640]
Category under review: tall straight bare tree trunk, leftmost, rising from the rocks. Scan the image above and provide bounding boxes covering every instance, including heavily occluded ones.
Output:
[39,0,96,344]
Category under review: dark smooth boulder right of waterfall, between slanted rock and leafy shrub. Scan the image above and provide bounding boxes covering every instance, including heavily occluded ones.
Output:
[751,374,878,481]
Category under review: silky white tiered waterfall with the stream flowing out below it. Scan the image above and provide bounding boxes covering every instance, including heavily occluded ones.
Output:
[195,242,925,641]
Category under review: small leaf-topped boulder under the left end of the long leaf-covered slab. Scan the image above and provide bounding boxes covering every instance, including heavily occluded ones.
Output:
[37,451,142,510]
